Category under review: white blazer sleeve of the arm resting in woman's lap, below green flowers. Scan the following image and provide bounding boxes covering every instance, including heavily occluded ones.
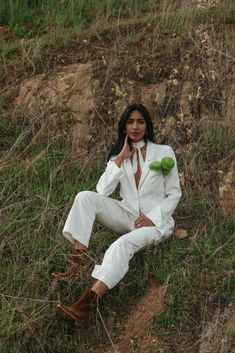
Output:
[146,146,182,228]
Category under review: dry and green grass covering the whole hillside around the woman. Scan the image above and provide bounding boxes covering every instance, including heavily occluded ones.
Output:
[0,0,235,353]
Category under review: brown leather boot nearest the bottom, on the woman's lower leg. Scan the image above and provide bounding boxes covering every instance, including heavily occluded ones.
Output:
[57,288,98,326]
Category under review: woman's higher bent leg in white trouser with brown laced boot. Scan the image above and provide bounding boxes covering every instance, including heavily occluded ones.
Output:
[53,191,133,284]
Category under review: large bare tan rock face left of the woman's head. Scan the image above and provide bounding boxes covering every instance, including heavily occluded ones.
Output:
[15,63,94,150]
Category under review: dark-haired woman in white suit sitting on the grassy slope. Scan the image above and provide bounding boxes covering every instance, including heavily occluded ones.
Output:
[53,103,181,325]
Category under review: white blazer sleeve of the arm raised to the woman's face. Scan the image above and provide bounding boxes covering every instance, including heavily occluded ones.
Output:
[96,158,123,196]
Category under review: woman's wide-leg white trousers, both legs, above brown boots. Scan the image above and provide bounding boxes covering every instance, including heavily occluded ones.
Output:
[63,191,165,289]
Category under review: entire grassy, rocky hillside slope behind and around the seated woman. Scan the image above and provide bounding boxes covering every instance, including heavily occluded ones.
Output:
[0,0,235,353]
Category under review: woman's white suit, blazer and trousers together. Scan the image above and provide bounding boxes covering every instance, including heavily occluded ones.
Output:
[63,141,181,288]
